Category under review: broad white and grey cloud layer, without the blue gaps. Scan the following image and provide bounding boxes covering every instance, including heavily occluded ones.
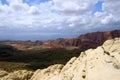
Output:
[0,0,120,39]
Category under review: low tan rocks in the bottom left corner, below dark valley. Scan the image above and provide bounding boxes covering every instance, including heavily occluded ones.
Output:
[0,70,33,80]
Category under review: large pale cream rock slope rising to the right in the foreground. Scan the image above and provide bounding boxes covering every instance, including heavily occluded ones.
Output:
[30,38,120,80]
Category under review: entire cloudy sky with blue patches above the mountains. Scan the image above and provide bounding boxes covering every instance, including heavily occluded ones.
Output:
[0,0,120,40]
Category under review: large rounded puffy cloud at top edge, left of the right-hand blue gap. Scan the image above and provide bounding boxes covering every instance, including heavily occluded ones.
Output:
[53,0,97,15]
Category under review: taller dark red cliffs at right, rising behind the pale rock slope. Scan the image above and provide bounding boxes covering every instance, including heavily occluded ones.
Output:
[45,30,120,49]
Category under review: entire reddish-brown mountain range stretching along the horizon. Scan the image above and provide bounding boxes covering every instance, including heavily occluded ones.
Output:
[2,30,120,50]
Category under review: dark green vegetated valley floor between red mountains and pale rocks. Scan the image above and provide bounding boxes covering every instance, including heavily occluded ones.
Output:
[0,44,84,72]
